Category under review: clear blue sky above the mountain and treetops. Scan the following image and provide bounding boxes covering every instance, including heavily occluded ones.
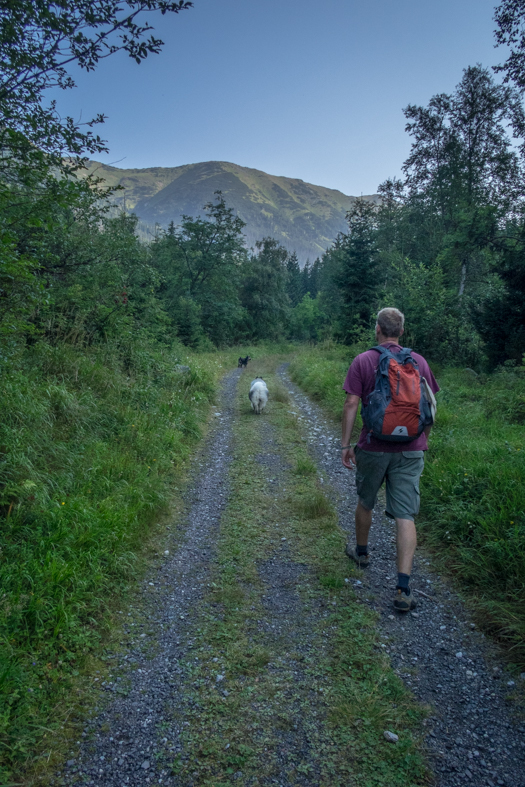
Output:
[57,0,503,195]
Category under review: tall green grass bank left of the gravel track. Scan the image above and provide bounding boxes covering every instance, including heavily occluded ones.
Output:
[0,341,228,778]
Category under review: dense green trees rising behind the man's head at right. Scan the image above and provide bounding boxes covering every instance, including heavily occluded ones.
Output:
[308,65,525,369]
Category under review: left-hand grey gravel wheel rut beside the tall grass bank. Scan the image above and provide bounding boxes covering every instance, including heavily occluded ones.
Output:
[55,370,240,787]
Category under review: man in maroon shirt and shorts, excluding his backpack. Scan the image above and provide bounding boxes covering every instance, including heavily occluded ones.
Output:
[341,309,439,612]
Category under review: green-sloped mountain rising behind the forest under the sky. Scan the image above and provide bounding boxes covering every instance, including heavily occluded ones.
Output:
[82,161,377,263]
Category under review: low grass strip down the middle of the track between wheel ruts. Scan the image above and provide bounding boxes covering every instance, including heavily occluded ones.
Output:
[173,358,427,787]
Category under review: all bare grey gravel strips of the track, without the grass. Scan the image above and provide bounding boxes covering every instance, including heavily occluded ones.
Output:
[54,365,525,787]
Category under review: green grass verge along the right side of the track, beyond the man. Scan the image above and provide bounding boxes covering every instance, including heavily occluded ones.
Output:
[290,346,525,667]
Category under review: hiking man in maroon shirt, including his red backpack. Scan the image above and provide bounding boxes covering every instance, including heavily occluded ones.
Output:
[341,309,439,612]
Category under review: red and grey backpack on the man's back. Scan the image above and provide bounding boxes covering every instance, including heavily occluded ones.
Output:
[361,345,435,443]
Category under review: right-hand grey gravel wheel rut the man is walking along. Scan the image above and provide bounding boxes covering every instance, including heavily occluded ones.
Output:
[279,364,525,787]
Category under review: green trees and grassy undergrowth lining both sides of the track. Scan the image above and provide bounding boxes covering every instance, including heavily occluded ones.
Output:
[0,0,525,778]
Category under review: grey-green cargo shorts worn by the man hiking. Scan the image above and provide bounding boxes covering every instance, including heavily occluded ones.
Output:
[355,448,425,520]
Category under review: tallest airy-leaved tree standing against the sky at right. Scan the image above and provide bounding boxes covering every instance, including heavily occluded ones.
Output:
[403,65,524,300]
